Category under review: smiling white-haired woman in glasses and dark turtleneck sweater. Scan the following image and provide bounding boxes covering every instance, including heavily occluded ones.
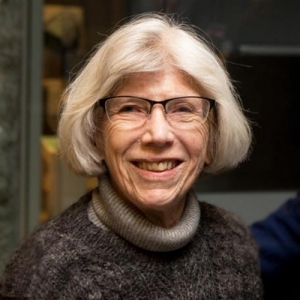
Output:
[0,15,262,300]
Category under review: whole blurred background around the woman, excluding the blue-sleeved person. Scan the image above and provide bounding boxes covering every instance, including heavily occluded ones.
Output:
[0,0,300,272]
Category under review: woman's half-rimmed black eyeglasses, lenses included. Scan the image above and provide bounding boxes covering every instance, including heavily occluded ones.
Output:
[97,96,215,127]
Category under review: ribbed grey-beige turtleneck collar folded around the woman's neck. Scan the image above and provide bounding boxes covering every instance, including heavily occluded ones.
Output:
[92,175,200,252]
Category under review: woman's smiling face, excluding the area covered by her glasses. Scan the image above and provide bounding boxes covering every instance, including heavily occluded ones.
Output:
[101,69,208,218]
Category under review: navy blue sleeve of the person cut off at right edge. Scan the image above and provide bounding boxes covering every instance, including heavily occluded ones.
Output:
[250,191,300,300]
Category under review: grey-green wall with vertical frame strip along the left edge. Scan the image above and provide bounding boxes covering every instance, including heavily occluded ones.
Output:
[0,0,43,273]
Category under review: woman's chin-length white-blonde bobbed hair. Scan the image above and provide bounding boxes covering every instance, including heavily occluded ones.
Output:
[58,14,252,176]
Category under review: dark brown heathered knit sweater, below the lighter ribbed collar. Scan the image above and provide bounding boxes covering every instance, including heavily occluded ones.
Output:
[0,177,262,300]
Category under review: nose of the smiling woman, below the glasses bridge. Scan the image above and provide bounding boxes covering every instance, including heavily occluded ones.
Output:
[141,105,174,147]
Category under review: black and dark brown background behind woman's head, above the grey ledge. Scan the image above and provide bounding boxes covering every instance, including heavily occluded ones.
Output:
[46,0,300,192]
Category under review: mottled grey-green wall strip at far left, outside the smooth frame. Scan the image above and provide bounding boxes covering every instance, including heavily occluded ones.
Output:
[0,0,24,270]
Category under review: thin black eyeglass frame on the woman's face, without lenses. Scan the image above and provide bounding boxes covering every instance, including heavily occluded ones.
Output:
[96,95,216,114]
